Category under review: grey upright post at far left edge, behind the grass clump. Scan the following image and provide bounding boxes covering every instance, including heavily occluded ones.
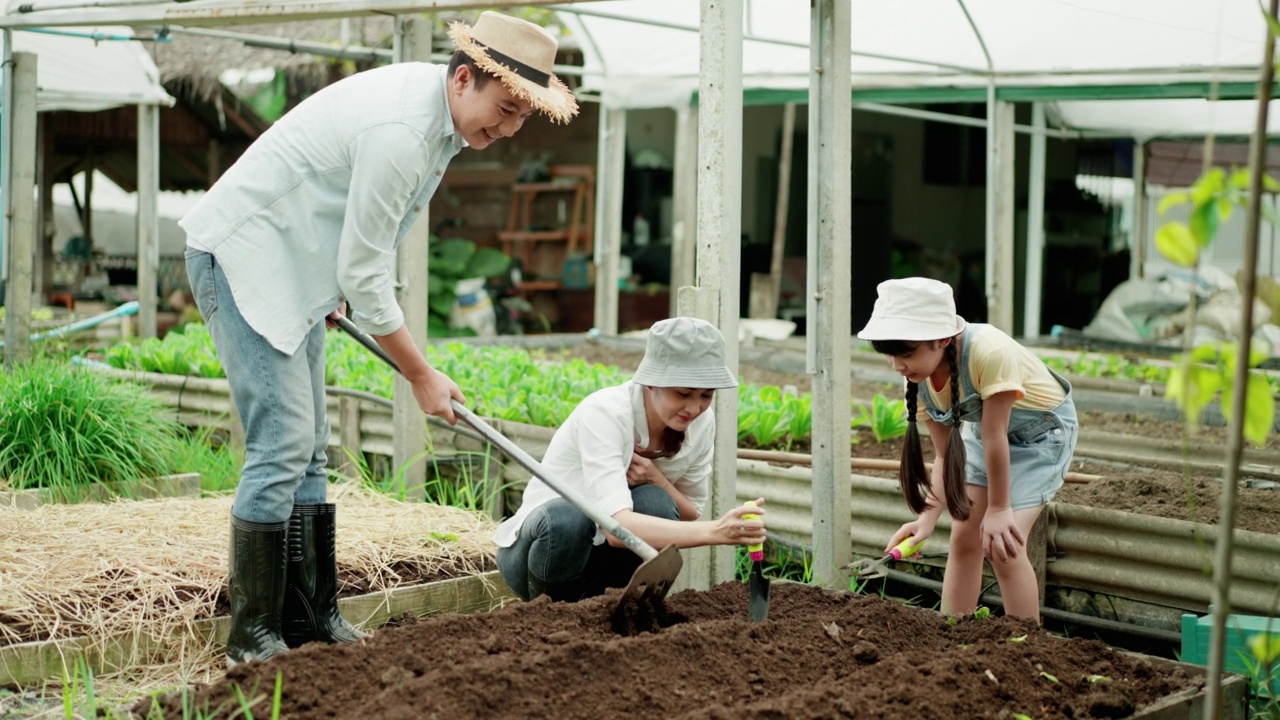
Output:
[4,50,36,368]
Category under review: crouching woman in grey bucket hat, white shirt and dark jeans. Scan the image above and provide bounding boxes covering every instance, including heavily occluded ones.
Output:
[494,318,764,601]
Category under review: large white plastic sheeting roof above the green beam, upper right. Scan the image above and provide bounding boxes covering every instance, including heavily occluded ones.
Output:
[557,0,1266,122]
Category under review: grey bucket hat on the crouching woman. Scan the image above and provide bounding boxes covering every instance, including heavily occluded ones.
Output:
[631,318,737,389]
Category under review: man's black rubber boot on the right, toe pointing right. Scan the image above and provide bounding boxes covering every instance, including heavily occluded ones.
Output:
[283,503,369,647]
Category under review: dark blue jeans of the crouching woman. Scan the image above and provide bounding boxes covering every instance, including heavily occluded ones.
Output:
[498,486,680,602]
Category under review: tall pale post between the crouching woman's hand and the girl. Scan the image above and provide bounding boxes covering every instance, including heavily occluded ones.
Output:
[808,0,852,588]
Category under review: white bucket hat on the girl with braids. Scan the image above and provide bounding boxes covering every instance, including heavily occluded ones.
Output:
[858,278,965,342]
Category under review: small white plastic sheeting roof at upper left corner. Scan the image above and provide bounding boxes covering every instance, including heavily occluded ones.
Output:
[0,27,174,113]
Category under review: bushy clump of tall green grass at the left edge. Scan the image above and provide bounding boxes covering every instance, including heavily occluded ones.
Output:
[0,359,179,491]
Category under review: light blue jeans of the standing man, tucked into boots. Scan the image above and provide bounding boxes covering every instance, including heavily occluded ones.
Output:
[187,249,329,523]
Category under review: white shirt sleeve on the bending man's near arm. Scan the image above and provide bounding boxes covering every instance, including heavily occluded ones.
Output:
[337,123,431,336]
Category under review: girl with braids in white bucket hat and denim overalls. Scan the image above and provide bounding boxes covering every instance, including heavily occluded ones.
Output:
[858,278,1079,620]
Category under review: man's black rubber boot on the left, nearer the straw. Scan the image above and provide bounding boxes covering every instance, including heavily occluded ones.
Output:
[227,515,289,665]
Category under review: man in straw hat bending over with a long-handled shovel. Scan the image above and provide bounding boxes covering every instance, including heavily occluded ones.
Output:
[180,13,577,665]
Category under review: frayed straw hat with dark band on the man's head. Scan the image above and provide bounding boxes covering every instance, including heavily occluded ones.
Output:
[449,12,577,123]
